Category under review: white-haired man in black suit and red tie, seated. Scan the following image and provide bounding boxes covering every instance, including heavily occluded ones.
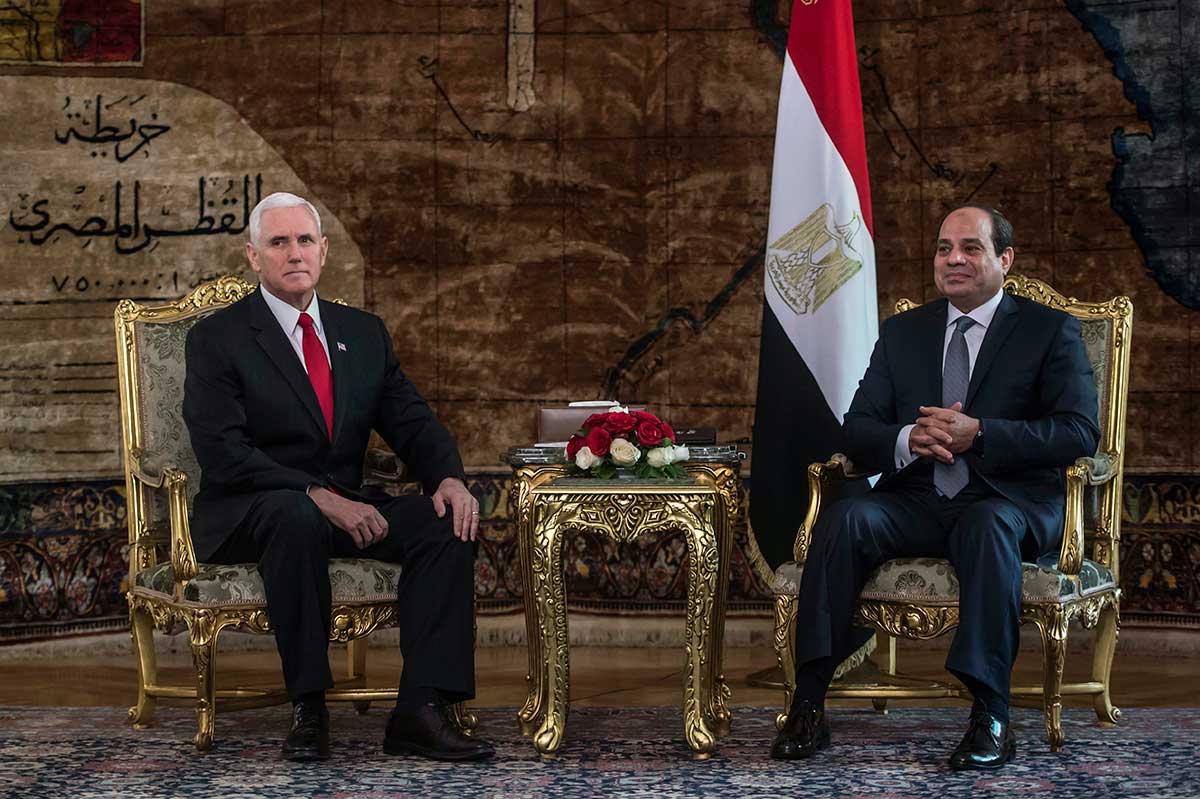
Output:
[184,193,493,761]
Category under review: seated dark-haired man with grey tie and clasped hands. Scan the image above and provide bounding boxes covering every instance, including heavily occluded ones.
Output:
[772,205,1099,769]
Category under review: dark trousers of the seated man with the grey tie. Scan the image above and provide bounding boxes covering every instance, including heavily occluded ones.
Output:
[796,465,1038,702]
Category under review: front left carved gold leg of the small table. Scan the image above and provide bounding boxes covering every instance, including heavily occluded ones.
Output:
[530,506,571,756]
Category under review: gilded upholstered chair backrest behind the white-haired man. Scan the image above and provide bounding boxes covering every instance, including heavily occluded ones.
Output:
[114,277,256,569]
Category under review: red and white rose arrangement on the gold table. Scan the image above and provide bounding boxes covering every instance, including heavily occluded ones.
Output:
[566,405,690,479]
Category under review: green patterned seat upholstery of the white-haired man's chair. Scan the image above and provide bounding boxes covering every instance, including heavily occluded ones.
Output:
[134,558,400,607]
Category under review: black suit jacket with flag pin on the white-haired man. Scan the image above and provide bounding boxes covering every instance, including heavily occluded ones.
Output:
[184,288,463,560]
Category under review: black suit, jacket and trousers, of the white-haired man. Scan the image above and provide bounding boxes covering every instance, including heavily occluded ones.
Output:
[184,288,474,699]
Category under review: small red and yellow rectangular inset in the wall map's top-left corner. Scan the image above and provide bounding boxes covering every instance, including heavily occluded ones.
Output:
[0,0,144,66]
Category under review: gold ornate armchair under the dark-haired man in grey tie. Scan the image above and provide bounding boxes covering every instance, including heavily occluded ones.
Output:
[773,276,1133,751]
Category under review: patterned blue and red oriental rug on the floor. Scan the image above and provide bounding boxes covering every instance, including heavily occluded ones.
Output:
[0,707,1200,799]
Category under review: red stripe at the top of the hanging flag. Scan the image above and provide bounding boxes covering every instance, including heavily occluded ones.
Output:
[787,0,875,239]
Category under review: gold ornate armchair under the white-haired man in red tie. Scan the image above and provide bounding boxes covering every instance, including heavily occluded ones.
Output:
[114,277,475,751]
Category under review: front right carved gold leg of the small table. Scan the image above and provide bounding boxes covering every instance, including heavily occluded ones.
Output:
[683,503,720,759]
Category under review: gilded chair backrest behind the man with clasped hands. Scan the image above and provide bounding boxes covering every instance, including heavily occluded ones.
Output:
[896,275,1133,573]
